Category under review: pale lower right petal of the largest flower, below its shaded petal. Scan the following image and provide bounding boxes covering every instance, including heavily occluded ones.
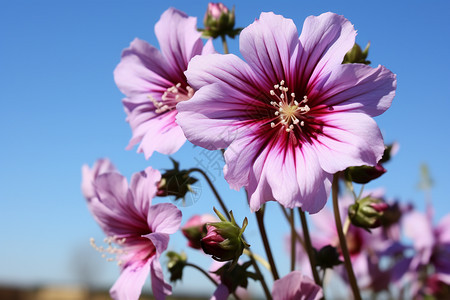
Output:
[314,112,384,174]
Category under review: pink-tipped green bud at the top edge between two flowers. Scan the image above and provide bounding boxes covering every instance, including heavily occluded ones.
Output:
[201,2,242,39]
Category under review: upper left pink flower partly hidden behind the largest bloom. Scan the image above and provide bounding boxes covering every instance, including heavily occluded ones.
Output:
[114,8,214,158]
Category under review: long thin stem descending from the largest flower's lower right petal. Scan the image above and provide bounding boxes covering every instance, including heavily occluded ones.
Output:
[332,174,361,300]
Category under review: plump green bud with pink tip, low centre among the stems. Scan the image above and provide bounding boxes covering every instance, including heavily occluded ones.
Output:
[201,209,250,262]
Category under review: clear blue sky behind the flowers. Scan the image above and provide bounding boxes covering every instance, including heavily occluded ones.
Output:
[0,0,450,292]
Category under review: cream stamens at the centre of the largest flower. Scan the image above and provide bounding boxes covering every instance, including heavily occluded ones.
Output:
[270,80,310,132]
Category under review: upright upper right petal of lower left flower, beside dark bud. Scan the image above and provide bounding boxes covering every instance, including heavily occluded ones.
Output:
[130,167,161,214]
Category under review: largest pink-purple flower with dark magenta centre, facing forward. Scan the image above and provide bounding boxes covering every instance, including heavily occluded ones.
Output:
[177,13,396,213]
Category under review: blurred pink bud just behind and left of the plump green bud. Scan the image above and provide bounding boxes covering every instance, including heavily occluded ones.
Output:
[181,214,217,249]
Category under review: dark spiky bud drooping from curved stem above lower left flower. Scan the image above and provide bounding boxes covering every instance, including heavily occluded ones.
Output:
[156,158,198,200]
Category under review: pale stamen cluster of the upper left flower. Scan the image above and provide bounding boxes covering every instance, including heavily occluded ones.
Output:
[148,83,194,114]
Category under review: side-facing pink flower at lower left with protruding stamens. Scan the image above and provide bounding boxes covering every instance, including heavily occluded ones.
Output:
[82,160,181,299]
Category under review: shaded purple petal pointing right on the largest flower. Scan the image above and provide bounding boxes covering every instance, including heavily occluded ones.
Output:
[308,64,397,116]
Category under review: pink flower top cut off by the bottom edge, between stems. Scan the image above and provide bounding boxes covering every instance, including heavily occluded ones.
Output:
[272,271,323,300]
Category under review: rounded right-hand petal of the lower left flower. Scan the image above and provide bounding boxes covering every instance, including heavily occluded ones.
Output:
[147,203,181,234]
